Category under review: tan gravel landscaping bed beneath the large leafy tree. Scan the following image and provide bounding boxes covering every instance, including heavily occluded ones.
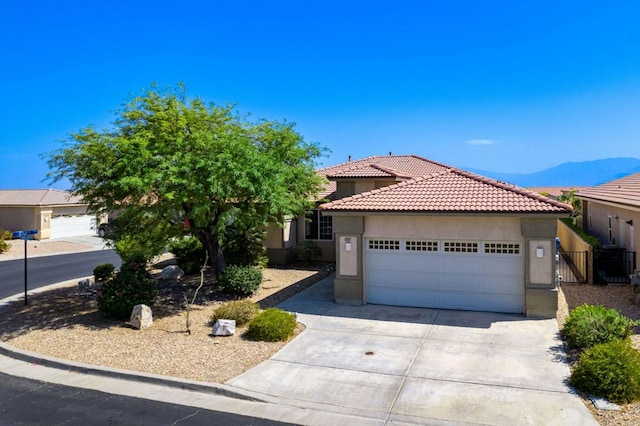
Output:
[0,264,330,383]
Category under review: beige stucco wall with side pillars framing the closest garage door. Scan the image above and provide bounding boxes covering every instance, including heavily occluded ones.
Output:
[333,215,558,318]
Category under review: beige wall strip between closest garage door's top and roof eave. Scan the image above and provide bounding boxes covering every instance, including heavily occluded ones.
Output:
[364,215,522,241]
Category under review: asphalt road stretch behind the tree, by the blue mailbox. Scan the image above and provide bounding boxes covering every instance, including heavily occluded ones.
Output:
[0,250,121,300]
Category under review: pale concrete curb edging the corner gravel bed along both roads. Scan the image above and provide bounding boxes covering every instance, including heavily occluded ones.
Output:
[0,275,267,402]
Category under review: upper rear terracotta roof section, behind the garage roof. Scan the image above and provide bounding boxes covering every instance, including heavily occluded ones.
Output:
[318,155,448,179]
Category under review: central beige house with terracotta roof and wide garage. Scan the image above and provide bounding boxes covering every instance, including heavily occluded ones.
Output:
[308,155,571,317]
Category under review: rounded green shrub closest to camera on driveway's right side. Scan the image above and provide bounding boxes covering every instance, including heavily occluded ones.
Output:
[569,339,640,403]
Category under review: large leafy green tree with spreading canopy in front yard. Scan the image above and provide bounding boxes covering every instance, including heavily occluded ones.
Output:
[48,85,324,273]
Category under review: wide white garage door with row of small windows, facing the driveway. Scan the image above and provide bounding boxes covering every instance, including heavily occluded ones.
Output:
[365,238,524,313]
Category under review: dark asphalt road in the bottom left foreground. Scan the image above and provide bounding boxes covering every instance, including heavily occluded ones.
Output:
[0,373,289,426]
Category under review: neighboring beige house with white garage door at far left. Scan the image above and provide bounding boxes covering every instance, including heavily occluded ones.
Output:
[0,189,96,240]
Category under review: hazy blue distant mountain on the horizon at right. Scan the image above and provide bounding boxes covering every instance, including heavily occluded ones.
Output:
[466,158,640,188]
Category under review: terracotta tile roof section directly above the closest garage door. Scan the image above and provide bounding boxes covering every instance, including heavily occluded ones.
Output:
[320,168,571,214]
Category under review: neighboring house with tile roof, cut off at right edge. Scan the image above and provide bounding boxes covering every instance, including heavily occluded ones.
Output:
[576,173,640,272]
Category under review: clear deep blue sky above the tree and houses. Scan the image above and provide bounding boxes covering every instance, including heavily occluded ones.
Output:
[0,0,640,189]
